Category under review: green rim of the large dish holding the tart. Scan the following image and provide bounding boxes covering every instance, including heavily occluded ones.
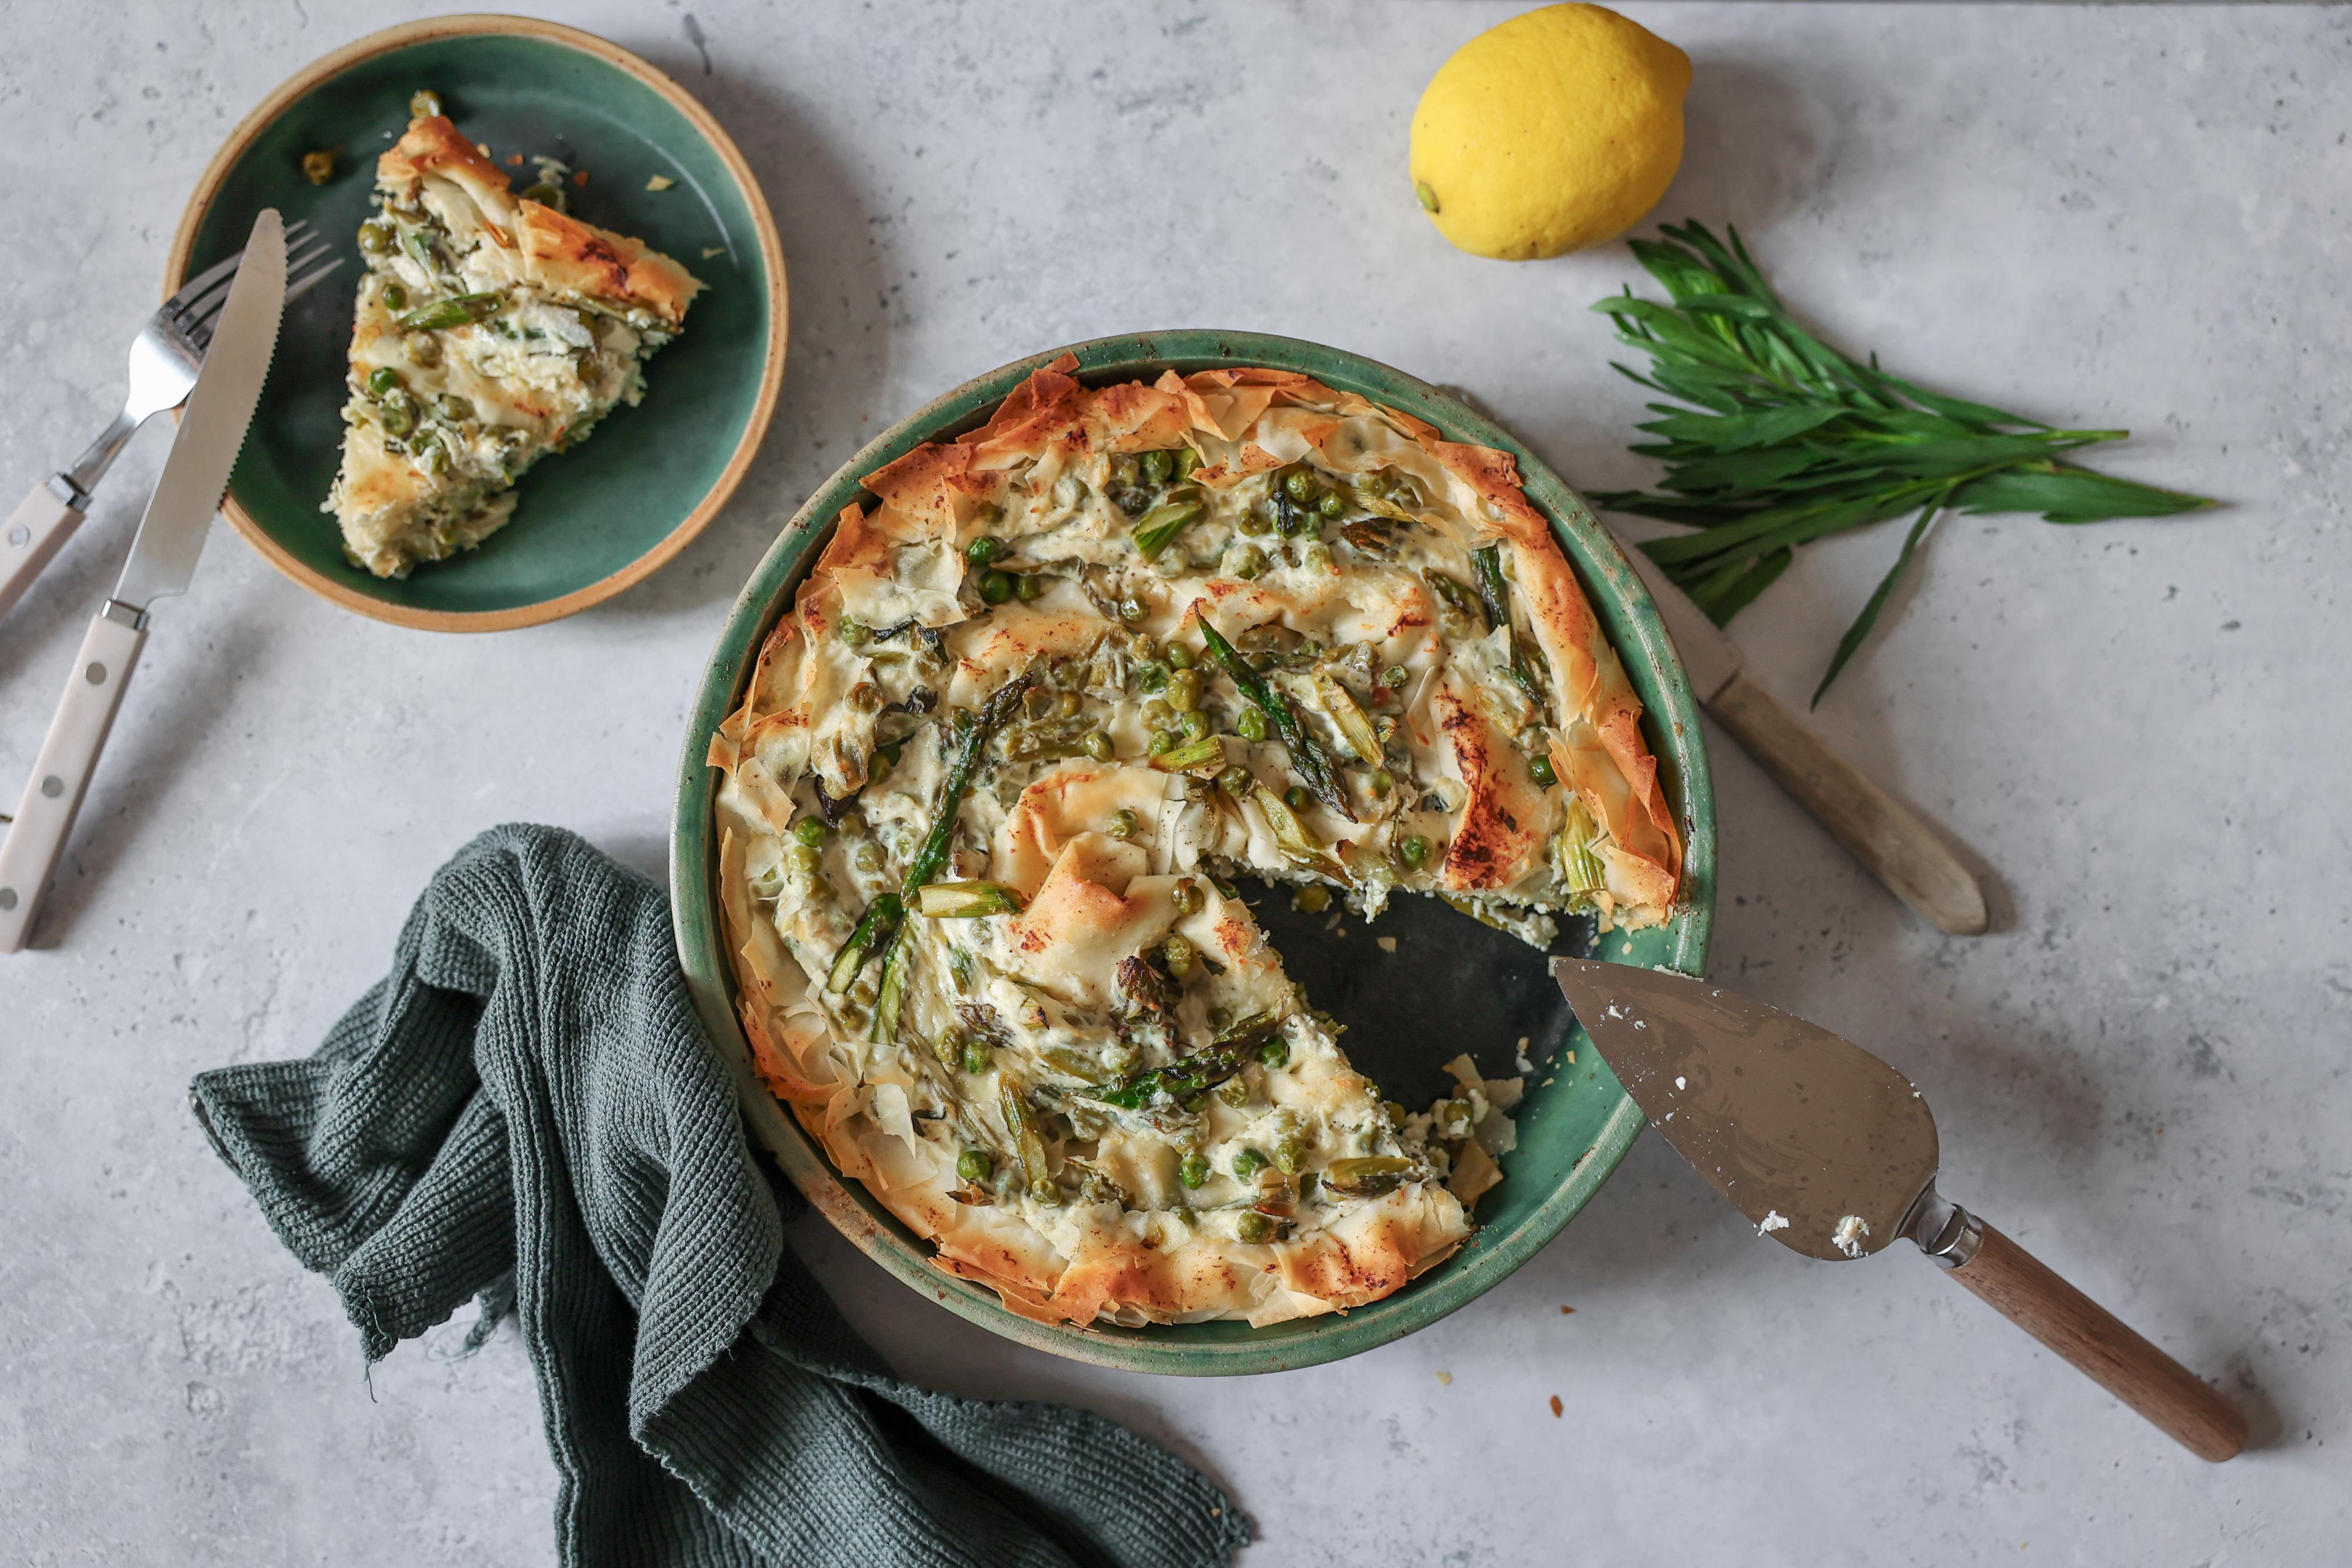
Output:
[670,329,1714,1375]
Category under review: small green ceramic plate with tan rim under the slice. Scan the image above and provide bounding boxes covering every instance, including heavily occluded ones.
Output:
[165,16,786,630]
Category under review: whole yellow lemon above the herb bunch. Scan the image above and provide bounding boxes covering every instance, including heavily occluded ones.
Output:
[1413,5,1691,261]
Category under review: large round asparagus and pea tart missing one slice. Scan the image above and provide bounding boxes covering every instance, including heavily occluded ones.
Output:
[710,358,1682,1323]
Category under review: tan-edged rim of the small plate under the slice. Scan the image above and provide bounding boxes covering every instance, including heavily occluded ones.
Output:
[162,12,788,632]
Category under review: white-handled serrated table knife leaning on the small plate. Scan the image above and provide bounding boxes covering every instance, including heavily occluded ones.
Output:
[0,209,287,952]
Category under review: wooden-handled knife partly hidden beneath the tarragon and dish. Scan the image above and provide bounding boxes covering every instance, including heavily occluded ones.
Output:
[1618,541,1990,936]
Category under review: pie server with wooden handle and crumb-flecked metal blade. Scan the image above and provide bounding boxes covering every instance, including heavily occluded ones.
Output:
[1552,959,2246,1462]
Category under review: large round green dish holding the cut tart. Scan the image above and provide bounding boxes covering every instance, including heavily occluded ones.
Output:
[670,332,1714,1375]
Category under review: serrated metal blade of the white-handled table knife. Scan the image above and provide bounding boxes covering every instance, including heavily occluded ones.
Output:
[115,207,287,611]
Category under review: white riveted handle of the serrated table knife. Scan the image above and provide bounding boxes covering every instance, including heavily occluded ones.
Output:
[0,602,146,952]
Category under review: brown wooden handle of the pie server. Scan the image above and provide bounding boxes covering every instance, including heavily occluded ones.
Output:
[1938,1215,2246,1464]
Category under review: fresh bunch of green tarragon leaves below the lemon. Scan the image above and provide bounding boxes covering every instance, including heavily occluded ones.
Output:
[1592,223,2216,705]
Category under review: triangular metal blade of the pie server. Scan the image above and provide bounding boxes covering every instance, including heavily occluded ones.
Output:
[1552,959,1936,1260]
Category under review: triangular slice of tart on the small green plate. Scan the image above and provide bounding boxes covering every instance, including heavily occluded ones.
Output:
[320,107,703,578]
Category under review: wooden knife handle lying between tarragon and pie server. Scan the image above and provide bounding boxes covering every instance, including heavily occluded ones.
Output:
[1707,670,1990,936]
